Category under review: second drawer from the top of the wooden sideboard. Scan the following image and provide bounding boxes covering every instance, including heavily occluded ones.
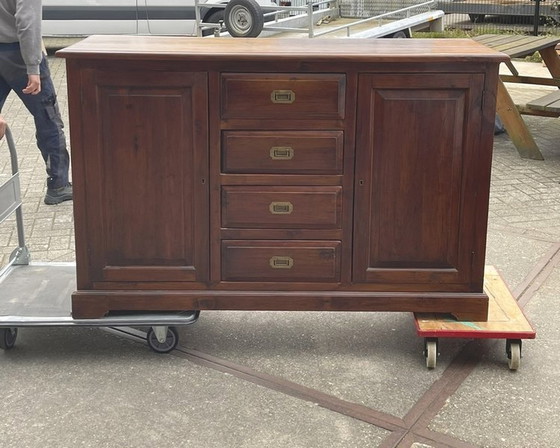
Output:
[222,131,344,174]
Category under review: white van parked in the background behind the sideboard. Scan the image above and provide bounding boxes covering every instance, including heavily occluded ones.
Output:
[43,0,271,37]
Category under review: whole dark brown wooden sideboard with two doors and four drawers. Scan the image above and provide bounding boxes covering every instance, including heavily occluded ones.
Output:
[57,36,507,320]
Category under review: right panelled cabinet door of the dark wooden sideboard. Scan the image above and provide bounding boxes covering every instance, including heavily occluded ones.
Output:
[353,74,491,290]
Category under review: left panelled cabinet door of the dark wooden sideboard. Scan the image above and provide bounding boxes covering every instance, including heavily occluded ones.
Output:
[77,70,208,282]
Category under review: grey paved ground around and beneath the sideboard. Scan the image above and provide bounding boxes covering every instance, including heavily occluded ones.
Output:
[0,39,560,448]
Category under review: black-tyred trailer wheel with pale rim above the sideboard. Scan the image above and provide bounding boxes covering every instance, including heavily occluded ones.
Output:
[224,0,264,37]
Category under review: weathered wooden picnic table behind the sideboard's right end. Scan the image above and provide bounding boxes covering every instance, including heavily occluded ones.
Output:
[474,34,560,160]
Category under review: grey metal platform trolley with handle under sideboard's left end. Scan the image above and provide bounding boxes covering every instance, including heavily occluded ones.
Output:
[0,129,200,353]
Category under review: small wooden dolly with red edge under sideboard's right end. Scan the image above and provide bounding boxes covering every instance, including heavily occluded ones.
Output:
[414,266,536,370]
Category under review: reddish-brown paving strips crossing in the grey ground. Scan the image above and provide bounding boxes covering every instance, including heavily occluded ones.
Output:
[101,234,560,448]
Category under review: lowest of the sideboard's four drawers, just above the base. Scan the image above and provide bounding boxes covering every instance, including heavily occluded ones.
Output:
[222,240,341,282]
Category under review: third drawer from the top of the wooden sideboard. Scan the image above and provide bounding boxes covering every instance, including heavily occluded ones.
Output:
[222,186,342,229]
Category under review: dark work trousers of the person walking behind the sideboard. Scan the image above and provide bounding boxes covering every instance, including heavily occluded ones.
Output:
[0,43,69,188]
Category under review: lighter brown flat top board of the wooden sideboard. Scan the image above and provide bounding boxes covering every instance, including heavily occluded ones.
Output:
[57,35,509,63]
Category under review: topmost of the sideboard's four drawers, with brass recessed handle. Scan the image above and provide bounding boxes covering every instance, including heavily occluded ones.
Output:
[221,73,346,120]
